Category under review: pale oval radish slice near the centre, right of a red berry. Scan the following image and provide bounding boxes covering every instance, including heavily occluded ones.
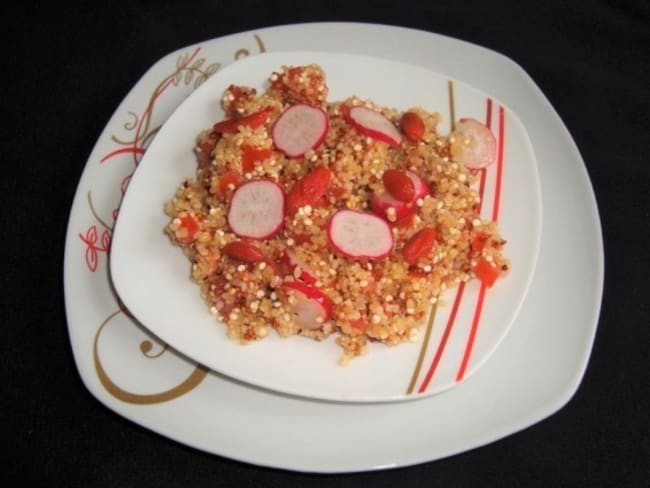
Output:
[327,209,393,260]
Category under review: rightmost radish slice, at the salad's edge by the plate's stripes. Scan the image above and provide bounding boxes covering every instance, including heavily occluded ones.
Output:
[450,119,497,169]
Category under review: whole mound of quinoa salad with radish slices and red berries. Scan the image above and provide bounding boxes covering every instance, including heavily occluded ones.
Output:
[165,64,510,364]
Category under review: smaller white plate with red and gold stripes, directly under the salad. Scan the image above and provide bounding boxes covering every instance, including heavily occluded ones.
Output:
[110,51,541,402]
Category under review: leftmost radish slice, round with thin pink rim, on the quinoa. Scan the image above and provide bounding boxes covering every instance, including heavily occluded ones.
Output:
[228,180,284,239]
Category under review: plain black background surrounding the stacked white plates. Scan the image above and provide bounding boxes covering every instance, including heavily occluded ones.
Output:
[6,0,650,487]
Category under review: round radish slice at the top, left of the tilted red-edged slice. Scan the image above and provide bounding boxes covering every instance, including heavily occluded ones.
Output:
[272,103,329,157]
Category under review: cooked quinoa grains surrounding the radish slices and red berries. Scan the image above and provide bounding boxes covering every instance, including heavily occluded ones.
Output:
[164,64,510,364]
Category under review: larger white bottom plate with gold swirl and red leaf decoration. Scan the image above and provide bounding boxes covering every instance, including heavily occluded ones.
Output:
[64,23,603,472]
